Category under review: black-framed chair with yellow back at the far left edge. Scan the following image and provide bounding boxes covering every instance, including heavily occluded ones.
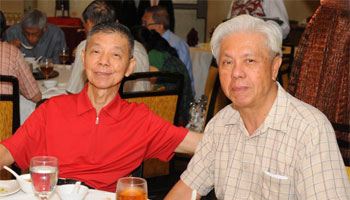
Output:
[0,75,20,179]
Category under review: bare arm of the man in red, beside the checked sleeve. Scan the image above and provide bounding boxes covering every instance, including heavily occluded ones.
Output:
[175,131,203,154]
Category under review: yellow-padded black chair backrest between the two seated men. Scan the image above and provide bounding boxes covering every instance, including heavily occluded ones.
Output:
[119,72,183,178]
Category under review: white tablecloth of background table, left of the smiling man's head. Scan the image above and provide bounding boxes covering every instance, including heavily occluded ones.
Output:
[19,65,72,125]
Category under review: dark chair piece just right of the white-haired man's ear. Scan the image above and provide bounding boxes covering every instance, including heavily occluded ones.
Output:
[277,43,295,89]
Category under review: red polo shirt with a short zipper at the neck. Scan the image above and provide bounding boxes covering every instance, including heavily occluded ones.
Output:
[2,83,188,192]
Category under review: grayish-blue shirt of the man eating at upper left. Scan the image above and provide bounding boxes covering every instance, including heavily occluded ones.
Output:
[5,24,66,64]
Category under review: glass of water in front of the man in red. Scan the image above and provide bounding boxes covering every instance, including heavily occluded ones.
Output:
[30,156,58,200]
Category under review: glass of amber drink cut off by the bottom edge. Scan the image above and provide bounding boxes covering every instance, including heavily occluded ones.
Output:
[117,177,147,200]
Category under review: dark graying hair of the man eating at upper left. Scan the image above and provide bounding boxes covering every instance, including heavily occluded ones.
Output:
[21,9,46,30]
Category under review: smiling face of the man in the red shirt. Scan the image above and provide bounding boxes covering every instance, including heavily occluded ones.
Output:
[82,32,135,89]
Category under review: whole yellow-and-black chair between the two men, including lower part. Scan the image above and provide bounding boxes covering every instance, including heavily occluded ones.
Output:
[119,71,184,199]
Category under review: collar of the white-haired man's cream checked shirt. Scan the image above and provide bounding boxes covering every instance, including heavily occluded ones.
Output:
[225,82,289,133]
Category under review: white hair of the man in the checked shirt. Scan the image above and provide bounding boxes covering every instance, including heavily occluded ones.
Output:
[210,15,282,61]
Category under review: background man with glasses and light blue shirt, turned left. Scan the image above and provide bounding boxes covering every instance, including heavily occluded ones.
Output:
[142,6,195,96]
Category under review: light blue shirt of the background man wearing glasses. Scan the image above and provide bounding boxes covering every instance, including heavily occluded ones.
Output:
[162,30,195,96]
